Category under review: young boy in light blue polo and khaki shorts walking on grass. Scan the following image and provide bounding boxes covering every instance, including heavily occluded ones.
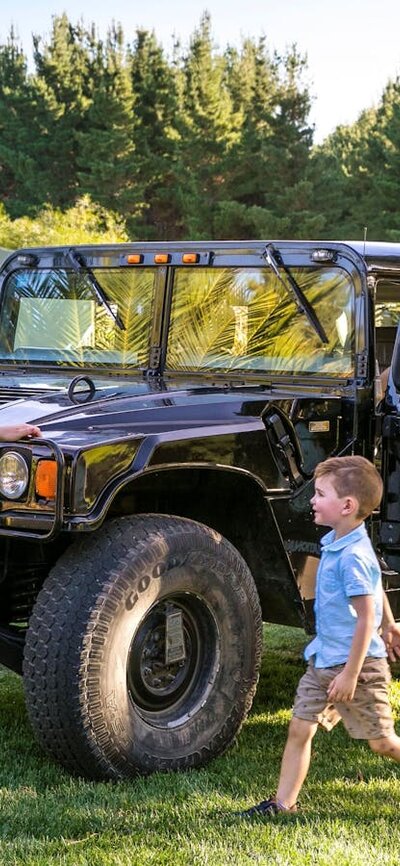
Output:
[240,456,400,817]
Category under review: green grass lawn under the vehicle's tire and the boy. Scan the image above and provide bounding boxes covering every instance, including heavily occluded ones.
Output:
[0,626,400,866]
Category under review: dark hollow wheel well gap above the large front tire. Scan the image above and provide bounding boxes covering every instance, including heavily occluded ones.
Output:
[106,465,303,626]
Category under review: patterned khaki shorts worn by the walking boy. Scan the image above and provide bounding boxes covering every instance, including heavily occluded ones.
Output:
[293,657,394,740]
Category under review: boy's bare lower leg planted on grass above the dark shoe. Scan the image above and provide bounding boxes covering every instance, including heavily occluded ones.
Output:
[276,717,318,809]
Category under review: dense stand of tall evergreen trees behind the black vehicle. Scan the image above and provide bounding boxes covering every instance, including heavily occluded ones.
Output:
[0,12,400,247]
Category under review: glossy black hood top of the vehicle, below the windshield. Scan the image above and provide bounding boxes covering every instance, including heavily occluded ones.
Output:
[0,370,276,447]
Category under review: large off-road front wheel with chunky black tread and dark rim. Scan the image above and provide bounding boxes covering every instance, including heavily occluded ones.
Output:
[24,515,261,779]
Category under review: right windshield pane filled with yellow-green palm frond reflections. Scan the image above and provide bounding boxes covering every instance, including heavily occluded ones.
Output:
[167,267,355,377]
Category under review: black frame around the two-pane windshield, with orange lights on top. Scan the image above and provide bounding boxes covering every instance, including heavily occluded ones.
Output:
[0,239,368,388]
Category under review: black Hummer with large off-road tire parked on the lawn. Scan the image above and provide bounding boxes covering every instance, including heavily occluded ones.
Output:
[0,241,400,779]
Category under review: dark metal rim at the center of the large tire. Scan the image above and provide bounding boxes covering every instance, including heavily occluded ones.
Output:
[127,593,220,724]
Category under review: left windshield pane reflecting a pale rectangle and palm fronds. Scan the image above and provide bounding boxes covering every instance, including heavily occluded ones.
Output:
[0,268,155,368]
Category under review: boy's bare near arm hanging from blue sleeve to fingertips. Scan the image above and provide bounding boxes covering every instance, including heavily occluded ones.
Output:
[328,595,375,702]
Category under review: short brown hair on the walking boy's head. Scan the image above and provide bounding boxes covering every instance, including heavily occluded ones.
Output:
[314,454,383,519]
